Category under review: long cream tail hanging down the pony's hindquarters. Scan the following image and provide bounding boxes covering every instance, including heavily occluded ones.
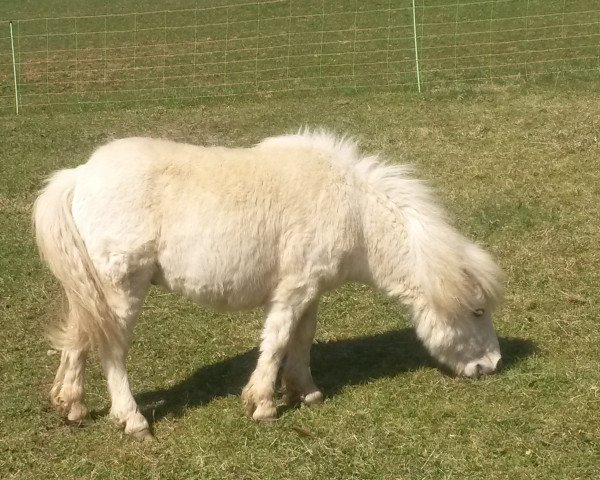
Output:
[33,169,122,350]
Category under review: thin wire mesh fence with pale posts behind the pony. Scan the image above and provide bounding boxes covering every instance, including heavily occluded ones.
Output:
[0,0,600,113]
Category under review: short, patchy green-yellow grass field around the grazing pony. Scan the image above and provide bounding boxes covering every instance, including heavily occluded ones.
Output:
[0,0,600,480]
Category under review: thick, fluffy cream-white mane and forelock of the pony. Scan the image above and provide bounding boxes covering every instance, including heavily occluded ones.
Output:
[259,129,503,315]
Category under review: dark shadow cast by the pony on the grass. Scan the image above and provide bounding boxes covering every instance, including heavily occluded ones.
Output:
[136,328,535,422]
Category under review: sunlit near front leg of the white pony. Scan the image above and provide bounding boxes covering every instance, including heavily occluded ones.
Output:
[242,303,310,420]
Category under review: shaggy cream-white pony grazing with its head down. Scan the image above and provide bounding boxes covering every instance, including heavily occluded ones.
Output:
[33,132,501,439]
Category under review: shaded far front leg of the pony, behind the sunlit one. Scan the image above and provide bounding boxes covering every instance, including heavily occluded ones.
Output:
[282,302,323,405]
